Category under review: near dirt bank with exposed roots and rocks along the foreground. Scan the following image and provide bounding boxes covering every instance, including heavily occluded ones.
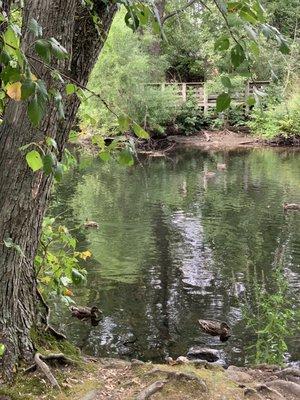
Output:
[0,357,300,400]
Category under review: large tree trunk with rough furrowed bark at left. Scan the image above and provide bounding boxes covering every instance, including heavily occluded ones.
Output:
[0,0,116,378]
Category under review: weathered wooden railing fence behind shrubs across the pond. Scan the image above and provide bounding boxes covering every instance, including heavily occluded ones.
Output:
[149,81,270,111]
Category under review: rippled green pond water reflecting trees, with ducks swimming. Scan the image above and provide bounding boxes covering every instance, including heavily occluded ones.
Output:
[50,149,300,365]
